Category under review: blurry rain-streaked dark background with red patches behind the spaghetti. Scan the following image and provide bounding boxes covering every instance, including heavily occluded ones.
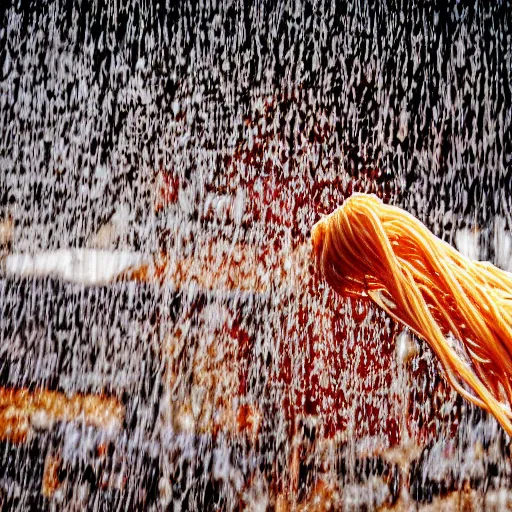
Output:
[0,0,512,510]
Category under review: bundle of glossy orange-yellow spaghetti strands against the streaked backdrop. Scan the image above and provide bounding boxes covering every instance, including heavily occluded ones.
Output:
[311,194,512,435]
